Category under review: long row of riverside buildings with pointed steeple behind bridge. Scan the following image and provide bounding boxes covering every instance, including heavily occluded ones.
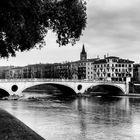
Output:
[1,45,135,81]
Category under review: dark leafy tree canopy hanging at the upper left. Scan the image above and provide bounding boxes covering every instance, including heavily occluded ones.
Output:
[0,0,87,57]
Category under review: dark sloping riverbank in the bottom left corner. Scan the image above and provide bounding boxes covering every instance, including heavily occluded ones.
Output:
[0,109,45,140]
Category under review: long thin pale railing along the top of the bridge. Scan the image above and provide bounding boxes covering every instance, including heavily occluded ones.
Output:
[0,78,125,84]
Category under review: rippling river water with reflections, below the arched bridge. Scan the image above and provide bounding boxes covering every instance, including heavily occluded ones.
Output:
[0,93,140,140]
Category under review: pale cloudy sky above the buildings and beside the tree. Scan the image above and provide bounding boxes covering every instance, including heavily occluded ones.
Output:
[0,0,140,66]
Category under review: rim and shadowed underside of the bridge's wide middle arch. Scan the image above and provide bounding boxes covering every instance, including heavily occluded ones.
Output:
[21,83,76,96]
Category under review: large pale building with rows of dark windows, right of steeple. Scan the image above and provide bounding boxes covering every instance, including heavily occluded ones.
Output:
[93,56,134,81]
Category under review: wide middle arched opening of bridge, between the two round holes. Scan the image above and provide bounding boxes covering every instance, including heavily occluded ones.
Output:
[23,83,76,97]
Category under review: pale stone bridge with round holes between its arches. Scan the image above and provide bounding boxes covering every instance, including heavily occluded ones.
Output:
[0,79,129,95]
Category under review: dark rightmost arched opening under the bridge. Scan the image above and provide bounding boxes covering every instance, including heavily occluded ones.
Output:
[85,85,124,96]
